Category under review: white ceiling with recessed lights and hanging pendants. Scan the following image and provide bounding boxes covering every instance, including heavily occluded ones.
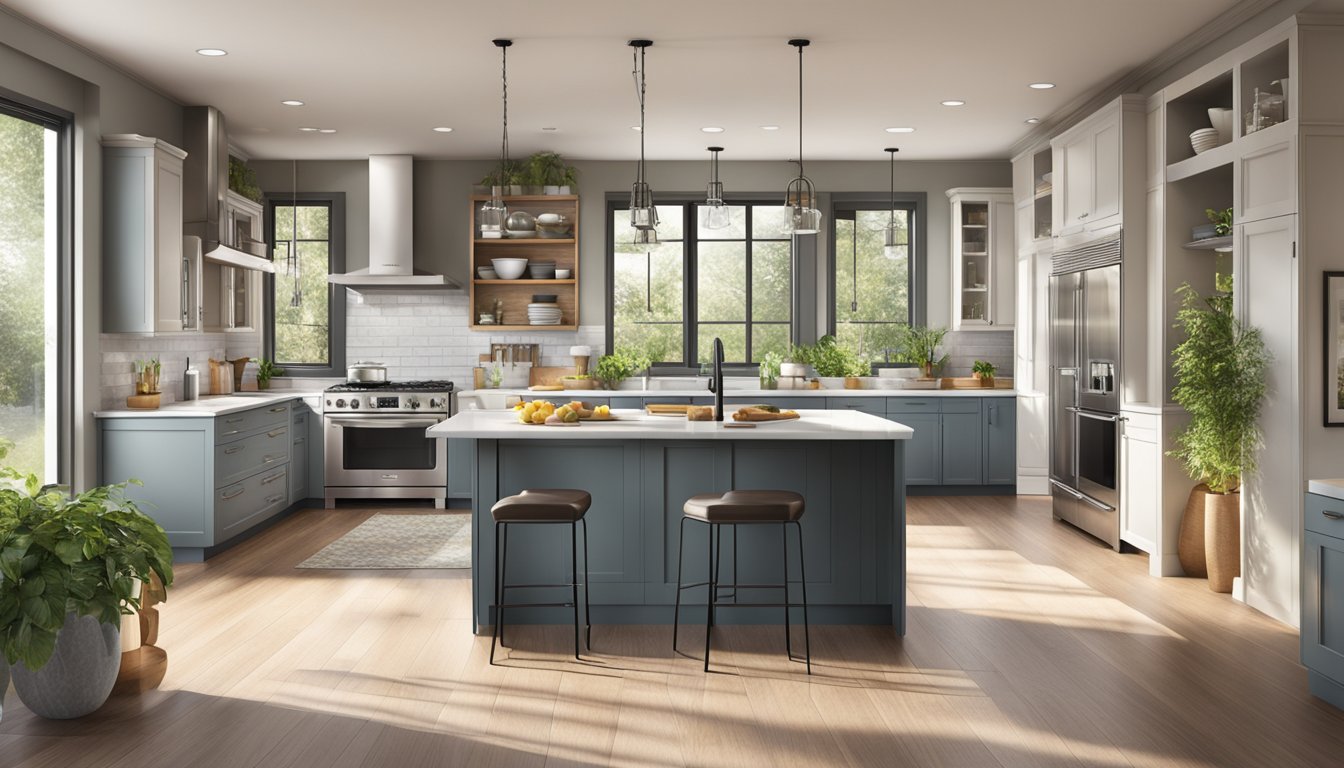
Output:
[0,0,1236,160]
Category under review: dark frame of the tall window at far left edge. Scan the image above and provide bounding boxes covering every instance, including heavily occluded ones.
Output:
[0,87,79,486]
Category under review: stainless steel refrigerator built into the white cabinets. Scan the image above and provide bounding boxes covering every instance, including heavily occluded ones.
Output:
[1050,238,1121,550]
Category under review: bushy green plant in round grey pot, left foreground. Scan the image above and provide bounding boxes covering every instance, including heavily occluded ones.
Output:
[0,440,172,718]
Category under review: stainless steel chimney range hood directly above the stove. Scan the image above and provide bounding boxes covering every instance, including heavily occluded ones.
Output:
[327,155,461,293]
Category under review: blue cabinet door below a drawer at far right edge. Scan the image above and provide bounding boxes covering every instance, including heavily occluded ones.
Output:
[1301,531,1344,681]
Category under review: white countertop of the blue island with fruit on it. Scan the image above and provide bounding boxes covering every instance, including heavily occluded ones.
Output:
[426,409,914,440]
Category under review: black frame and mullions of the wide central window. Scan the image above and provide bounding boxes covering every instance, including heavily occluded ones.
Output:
[605,192,800,373]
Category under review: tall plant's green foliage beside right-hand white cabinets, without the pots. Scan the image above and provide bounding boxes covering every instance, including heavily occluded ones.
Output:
[1171,274,1270,494]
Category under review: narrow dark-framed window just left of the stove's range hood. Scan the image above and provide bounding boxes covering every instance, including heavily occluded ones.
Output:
[266,192,345,377]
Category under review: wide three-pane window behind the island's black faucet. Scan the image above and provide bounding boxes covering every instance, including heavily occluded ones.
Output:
[607,202,793,366]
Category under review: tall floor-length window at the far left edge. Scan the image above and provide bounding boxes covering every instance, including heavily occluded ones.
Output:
[0,98,73,483]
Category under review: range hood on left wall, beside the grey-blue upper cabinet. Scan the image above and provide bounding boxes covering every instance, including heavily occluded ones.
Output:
[181,106,276,272]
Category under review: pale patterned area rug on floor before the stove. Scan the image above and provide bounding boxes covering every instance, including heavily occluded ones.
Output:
[298,512,472,570]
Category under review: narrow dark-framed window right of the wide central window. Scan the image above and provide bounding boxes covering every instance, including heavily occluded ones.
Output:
[829,195,923,359]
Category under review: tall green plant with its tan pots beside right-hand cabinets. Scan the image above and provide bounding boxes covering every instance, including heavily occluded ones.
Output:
[1171,276,1270,592]
